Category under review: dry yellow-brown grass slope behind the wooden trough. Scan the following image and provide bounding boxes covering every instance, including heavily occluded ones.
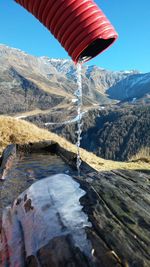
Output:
[0,116,150,170]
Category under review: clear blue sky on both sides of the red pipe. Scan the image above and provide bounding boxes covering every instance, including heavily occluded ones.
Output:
[0,0,150,72]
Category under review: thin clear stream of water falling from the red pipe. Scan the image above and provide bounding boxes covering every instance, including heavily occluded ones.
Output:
[74,63,82,176]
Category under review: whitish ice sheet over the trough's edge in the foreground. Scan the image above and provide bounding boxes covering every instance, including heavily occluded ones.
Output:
[2,174,92,266]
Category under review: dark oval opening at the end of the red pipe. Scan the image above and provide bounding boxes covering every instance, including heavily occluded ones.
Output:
[78,38,115,63]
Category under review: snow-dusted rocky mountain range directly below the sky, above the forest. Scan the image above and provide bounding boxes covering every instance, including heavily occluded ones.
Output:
[0,45,150,113]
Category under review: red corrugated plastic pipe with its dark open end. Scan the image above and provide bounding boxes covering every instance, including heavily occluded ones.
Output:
[15,0,118,63]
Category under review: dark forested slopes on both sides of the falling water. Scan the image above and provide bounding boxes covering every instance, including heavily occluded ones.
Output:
[28,105,150,161]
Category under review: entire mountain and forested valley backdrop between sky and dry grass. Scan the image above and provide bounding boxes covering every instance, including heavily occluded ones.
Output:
[0,45,150,161]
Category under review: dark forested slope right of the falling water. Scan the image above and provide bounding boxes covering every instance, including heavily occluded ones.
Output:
[82,106,150,160]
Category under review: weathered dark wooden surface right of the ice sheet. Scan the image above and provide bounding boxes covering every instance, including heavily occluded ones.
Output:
[80,170,150,267]
